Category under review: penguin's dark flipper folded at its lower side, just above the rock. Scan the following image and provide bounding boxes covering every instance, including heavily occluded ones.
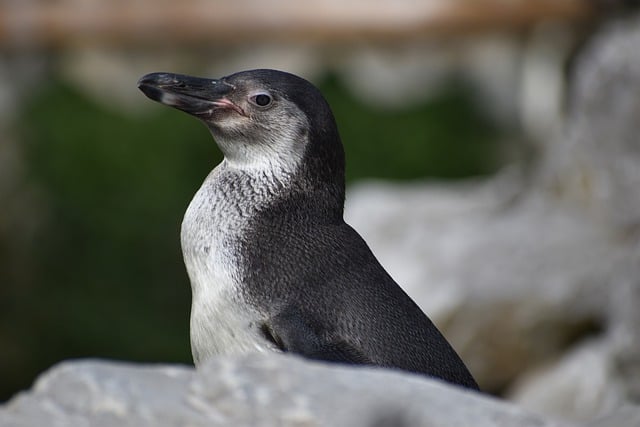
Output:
[262,310,373,365]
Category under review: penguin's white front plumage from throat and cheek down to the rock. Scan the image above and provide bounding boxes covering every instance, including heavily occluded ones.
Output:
[181,99,307,365]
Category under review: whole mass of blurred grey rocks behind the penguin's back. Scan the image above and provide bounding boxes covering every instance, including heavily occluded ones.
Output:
[346,13,640,420]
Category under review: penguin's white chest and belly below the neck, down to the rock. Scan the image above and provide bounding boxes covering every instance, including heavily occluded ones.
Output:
[181,169,282,365]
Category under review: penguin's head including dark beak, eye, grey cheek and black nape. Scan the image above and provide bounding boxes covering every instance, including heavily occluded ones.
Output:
[138,69,344,185]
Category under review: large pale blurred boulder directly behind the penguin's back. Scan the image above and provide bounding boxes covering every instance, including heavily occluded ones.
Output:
[347,176,628,391]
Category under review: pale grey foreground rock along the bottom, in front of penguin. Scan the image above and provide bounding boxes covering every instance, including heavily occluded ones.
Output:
[0,354,567,427]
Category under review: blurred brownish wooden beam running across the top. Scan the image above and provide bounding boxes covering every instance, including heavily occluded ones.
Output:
[0,0,593,49]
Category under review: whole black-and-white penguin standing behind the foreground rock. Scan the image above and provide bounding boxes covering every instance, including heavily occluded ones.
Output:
[138,69,478,390]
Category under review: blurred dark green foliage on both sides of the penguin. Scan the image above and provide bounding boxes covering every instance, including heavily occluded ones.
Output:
[0,71,503,399]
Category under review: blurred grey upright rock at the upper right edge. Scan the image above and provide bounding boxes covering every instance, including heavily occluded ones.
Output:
[540,15,640,228]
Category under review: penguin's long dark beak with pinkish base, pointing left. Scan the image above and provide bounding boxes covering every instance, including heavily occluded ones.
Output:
[138,73,245,119]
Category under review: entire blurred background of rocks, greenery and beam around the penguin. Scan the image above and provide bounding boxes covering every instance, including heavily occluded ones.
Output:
[0,0,640,419]
